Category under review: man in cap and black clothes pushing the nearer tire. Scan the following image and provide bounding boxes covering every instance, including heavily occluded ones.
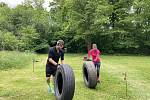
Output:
[46,40,64,93]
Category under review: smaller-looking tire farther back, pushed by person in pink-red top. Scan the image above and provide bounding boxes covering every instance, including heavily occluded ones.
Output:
[83,61,97,88]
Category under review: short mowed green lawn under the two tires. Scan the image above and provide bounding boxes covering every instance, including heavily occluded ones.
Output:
[0,54,150,100]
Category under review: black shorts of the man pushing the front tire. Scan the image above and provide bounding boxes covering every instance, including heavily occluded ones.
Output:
[46,64,57,77]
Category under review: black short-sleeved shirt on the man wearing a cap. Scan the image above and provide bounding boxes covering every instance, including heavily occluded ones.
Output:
[47,47,64,66]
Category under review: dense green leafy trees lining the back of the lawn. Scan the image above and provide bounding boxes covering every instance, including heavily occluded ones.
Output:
[0,0,150,54]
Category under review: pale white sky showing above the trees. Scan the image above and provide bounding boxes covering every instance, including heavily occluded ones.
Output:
[0,0,53,10]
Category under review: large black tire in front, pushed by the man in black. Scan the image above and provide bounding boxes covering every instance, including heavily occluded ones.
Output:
[55,64,75,100]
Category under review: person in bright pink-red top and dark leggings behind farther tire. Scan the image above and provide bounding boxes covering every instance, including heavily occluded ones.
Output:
[88,44,101,82]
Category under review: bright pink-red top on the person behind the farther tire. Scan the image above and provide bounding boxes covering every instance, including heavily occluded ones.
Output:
[88,49,101,63]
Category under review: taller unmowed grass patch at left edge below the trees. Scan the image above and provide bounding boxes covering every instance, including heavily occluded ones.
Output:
[0,51,35,70]
